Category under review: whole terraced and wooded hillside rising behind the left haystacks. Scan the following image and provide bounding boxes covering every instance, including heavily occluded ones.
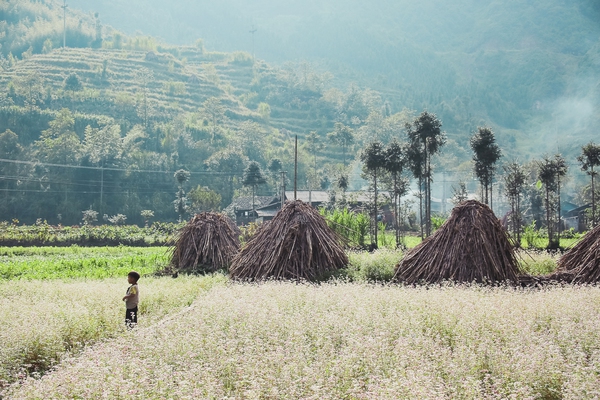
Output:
[0,46,380,224]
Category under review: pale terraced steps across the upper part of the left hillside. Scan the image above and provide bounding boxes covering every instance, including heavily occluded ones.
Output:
[0,47,342,143]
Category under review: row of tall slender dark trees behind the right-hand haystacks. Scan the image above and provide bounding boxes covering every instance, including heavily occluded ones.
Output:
[360,111,600,248]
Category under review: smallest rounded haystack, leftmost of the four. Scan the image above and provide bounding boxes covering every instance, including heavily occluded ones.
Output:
[171,212,240,272]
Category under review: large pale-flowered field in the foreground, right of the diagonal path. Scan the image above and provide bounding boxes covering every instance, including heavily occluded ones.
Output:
[8,282,600,399]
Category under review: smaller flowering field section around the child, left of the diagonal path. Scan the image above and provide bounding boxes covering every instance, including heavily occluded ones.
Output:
[0,273,225,398]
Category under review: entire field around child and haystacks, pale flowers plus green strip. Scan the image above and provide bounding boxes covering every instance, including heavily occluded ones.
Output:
[0,247,600,399]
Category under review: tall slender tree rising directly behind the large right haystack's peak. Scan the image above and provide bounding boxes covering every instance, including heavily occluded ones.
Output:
[470,127,502,207]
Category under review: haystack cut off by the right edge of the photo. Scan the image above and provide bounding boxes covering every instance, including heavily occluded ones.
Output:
[549,225,600,283]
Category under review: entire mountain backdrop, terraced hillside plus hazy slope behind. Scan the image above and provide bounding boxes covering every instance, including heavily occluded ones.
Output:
[0,0,600,224]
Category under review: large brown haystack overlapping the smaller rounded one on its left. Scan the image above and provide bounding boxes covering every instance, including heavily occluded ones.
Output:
[229,200,348,281]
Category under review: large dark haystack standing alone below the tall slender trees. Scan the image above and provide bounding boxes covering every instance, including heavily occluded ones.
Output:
[394,200,519,284]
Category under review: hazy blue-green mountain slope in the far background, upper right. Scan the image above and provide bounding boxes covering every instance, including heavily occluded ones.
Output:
[72,0,600,147]
